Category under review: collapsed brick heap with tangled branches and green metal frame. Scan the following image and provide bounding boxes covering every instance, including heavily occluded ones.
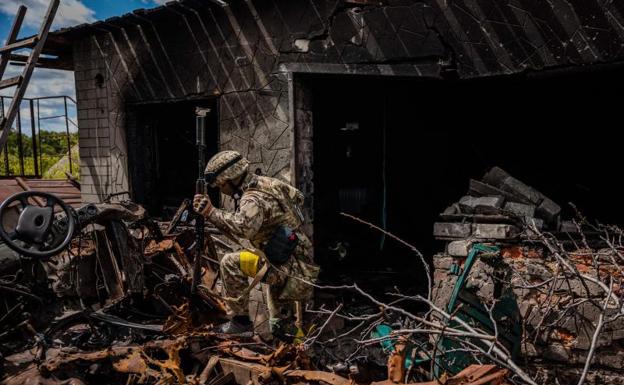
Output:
[433,168,624,383]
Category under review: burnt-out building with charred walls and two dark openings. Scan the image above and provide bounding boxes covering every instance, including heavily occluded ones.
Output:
[3,0,624,383]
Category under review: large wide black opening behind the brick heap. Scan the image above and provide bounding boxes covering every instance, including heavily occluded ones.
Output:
[300,68,624,284]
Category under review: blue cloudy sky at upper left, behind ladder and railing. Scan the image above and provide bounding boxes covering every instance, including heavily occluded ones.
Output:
[0,0,167,131]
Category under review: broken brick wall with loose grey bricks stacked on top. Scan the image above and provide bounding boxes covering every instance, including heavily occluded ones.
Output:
[432,168,624,384]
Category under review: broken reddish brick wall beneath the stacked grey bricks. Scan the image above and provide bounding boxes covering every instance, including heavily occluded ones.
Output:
[433,245,624,385]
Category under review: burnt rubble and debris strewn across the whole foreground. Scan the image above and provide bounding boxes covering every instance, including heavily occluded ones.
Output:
[0,168,624,385]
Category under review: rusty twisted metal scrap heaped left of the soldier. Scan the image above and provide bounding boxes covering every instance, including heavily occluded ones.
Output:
[0,198,506,385]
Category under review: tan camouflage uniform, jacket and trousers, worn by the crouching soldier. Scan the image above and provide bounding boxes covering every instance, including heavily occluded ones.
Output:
[206,174,318,322]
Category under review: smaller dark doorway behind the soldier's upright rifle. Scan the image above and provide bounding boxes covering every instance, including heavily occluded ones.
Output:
[127,99,218,219]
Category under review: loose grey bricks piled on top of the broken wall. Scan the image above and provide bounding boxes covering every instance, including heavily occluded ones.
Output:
[433,167,576,256]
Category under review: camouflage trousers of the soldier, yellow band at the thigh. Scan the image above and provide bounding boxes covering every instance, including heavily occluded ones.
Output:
[221,252,312,323]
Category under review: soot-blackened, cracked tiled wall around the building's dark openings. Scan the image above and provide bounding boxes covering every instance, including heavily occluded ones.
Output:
[68,0,624,201]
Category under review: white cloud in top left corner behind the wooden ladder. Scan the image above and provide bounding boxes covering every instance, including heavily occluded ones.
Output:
[0,0,96,30]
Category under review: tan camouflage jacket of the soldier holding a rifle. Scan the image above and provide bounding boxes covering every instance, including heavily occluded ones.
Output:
[207,174,312,261]
